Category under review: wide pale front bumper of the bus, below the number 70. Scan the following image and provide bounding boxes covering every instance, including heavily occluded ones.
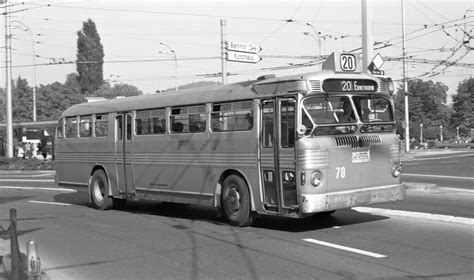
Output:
[299,184,406,214]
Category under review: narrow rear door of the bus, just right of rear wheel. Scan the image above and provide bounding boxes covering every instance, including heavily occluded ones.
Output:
[115,112,133,196]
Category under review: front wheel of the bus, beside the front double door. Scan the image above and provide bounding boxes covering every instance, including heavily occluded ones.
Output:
[222,175,256,227]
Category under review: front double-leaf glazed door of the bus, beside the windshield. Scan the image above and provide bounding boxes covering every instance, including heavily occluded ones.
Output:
[260,98,298,212]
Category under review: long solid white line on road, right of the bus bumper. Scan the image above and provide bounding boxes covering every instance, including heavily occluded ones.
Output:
[352,207,474,226]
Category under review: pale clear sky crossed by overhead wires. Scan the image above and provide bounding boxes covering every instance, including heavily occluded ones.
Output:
[0,0,474,101]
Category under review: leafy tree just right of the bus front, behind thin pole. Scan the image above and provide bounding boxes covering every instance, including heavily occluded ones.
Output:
[394,79,452,139]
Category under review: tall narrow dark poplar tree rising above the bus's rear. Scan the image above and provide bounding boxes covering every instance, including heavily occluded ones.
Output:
[76,19,104,94]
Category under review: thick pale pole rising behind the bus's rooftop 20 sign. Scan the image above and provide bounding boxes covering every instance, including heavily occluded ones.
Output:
[362,0,374,74]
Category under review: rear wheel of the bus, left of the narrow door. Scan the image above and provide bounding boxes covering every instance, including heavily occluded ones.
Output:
[89,169,112,210]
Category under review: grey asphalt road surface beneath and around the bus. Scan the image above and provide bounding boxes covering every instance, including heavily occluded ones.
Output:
[0,158,474,279]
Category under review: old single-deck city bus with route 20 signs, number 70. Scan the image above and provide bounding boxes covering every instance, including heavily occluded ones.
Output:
[55,53,405,226]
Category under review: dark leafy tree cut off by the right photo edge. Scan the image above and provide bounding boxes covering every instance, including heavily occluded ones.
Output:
[451,78,474,137]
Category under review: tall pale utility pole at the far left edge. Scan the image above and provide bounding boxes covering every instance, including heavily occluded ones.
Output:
[5,0,13,158]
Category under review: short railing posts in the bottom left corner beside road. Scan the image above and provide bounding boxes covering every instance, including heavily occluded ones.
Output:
[0,209,41,280]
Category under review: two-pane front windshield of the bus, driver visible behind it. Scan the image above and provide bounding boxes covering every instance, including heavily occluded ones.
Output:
[302,95,395,135]
